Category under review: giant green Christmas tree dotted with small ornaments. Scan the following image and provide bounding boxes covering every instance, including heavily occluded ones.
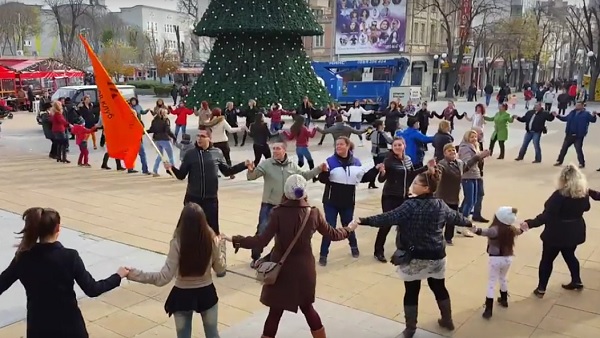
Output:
[187,0,330,109]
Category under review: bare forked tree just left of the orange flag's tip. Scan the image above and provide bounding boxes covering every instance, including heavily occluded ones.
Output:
[45,0,89,65]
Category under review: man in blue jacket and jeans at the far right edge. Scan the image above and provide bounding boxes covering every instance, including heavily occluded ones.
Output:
[552,102,598,168]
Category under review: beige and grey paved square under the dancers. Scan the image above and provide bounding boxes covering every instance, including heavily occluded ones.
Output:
[0,96,600,338]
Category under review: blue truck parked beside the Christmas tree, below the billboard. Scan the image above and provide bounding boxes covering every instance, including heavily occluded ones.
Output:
[312,57,410,122]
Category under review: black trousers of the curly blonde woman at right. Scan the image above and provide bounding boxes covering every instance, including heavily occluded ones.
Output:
[538,244,581,291]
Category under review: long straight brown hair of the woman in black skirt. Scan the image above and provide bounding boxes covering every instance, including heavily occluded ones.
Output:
[174,203,215,277]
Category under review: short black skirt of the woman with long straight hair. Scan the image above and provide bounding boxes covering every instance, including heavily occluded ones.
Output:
[165,284,219,317]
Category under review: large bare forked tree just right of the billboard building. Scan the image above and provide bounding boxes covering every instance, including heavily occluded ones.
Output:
[419,0,505,98]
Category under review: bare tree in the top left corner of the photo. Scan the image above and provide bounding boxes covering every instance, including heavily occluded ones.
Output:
[0,1,41,55]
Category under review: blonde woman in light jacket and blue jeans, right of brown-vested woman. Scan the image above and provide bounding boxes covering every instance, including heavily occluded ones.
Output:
[458,129,489,231]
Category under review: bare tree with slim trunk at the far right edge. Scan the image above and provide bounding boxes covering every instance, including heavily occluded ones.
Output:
[566,1,600,101]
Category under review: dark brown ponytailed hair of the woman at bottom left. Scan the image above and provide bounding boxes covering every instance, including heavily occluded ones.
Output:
[16,207,60,257]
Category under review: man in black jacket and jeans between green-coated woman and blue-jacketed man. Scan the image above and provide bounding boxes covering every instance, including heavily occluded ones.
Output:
[514,102,554,163]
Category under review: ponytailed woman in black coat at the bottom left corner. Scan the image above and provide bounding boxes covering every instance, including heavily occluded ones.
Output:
[0,208,129,338]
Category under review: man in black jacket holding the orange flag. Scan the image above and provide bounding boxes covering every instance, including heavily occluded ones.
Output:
[165,126,252,235]
